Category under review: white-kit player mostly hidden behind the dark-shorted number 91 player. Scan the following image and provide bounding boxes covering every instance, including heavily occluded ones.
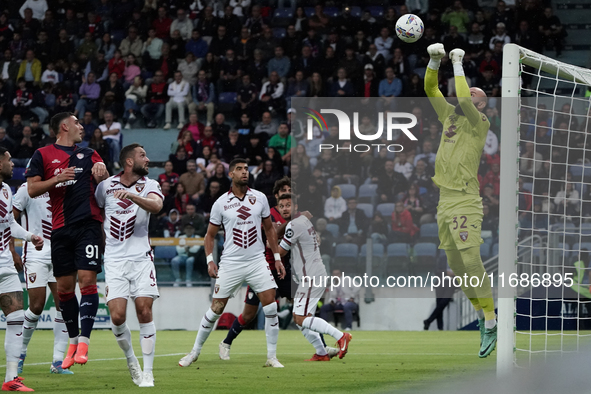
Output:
[12,183,74,375]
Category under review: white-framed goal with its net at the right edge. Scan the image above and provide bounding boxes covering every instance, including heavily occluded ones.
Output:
[495,44,591,374]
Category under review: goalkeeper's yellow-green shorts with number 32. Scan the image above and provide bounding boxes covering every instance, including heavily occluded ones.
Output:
[437,190,484,250]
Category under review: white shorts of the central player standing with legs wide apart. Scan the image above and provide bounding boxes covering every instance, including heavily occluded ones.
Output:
[213,256,277,298]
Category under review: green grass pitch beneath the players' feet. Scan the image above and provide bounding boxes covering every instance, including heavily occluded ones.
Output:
[6,330,496,394]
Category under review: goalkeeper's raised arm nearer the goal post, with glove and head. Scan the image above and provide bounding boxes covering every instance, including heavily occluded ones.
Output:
[449,48,488,127]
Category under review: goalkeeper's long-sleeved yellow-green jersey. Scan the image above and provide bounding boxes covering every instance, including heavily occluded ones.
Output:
[425,67,490,195]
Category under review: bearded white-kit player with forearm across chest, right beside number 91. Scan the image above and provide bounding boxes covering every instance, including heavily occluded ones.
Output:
[95,144,164,387]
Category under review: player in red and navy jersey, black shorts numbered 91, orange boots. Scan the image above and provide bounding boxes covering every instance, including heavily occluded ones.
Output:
[25,112,109,369]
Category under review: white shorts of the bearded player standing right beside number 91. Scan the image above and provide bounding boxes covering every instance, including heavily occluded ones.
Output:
[104,258,160,302]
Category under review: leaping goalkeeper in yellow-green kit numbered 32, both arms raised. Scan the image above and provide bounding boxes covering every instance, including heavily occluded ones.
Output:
[425,44,497,358]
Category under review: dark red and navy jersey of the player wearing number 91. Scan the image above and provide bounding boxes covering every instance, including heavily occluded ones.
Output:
[25,144,103,230]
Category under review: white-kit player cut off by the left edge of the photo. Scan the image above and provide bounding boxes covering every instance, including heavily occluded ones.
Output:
[0,146,43,391]
